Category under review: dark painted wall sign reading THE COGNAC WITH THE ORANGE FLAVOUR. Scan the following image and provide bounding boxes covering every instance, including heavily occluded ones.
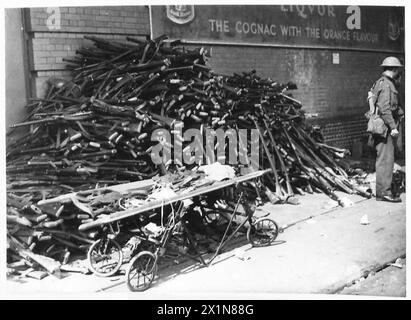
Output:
[151,5,404,52]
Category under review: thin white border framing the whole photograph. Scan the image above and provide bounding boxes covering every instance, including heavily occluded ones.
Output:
[0,0,411,300]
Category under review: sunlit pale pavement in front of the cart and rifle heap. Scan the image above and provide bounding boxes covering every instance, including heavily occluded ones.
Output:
[5,193,406,300]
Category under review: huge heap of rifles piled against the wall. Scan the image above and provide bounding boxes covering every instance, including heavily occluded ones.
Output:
[7,37,369,278]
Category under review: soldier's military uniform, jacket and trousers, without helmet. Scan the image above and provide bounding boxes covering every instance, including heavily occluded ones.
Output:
[373,74,404,197]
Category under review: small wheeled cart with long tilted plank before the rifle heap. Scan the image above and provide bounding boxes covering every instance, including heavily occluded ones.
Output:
[79,169,280,291]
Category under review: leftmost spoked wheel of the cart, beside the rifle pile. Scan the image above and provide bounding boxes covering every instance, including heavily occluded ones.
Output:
[87,239,123,277]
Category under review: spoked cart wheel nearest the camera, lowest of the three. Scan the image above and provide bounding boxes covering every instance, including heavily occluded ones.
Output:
[126,251,157,291]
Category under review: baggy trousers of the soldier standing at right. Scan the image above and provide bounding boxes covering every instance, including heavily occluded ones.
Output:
[375,135,394,197]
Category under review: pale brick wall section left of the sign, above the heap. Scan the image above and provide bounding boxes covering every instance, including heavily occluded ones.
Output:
[26,6,150,97]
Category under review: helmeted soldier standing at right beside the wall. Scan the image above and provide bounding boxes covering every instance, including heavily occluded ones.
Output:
[372,57,404,202]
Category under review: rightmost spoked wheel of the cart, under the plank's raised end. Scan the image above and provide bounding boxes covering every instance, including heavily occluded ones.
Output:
[247,218,279,247]
